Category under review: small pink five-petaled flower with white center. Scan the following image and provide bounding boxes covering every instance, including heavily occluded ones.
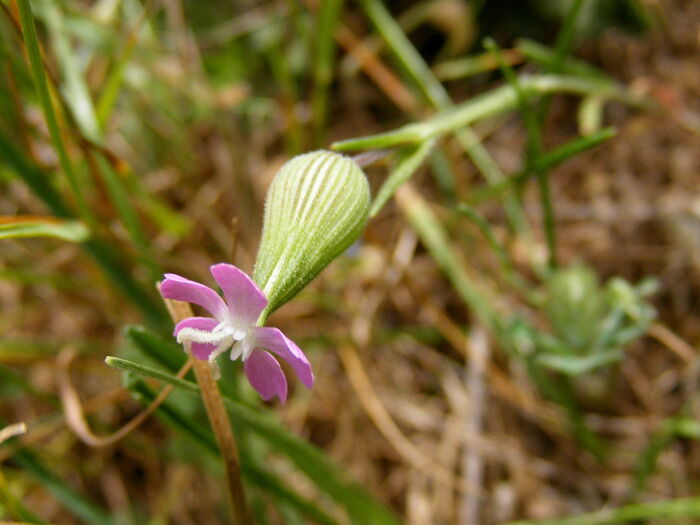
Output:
[160,263,314,402]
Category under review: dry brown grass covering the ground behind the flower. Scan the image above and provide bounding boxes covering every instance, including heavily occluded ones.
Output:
[0,0,700,525]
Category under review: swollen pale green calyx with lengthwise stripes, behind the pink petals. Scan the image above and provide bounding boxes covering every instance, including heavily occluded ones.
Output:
[253,151,370,322]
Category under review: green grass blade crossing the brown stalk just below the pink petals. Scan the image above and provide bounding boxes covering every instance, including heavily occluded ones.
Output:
[107,357,399,525]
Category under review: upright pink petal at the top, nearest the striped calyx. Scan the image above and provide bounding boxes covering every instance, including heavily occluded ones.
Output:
[211,263,267,325]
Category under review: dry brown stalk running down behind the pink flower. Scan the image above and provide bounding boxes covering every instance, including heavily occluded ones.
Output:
[165,299,253,525]
